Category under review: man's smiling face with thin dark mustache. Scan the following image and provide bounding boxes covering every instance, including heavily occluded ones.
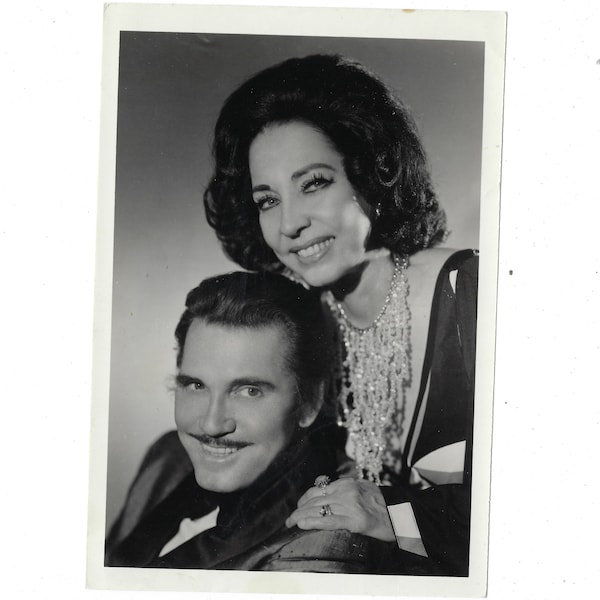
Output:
[175,319,307,493]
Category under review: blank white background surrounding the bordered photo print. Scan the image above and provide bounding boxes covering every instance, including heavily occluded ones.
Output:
[0,0,600,600]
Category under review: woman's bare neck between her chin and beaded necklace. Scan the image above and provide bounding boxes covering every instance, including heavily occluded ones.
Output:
[331,250,394,328]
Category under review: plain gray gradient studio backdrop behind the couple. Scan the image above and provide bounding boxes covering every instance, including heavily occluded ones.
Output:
[107,32,484,526]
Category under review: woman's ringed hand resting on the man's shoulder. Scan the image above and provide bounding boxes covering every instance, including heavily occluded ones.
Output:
[285,478,396,542]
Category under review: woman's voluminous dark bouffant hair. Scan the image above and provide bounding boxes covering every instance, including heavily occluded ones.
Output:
[204,55,446,271]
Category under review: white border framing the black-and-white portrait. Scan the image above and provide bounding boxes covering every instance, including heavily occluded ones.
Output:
[87,4,506,596]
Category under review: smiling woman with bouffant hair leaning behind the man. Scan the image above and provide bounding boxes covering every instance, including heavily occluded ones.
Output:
[204,55,477,575]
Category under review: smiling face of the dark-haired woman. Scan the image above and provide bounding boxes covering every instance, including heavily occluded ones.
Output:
[249,121,371,287]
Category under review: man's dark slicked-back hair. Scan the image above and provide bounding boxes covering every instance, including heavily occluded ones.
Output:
[175,271,332,406]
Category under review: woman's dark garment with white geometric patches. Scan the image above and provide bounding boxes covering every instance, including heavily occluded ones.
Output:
[380,250,478,576]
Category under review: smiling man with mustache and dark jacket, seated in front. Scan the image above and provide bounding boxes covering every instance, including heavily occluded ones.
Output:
[105,273,395,573]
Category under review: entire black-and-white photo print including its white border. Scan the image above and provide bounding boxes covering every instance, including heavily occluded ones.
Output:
[87,4,506,596]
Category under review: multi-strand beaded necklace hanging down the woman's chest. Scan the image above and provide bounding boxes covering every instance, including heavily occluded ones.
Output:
[325,255,411,484]
